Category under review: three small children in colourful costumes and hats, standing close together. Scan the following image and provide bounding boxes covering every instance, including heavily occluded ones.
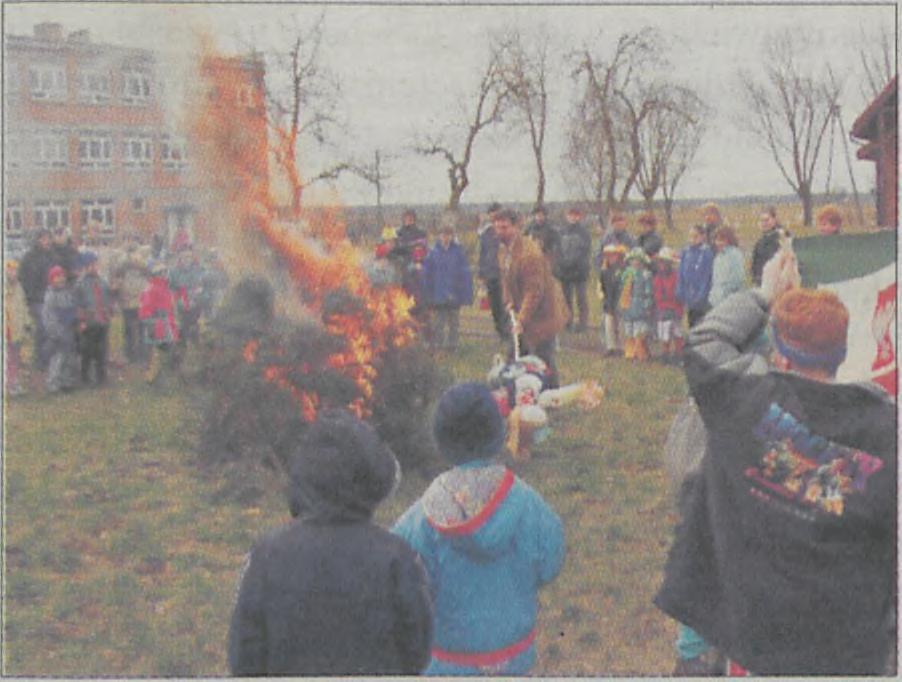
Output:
[598,244,683,362]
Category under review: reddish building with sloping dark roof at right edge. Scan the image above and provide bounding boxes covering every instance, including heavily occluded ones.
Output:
[852,77,899,227]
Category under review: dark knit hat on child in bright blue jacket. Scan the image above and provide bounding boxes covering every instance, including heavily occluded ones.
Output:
[432,382,504,464]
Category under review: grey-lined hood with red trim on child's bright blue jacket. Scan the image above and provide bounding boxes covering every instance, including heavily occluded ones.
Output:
[423,461,520,560]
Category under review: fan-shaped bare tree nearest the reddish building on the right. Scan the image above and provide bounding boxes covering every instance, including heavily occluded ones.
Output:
[740,33,841,225]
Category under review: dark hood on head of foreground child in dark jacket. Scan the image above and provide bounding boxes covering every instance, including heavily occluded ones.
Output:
[288,410,401,521]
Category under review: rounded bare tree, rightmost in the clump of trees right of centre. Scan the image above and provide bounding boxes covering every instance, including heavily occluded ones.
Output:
[636,85,711,229]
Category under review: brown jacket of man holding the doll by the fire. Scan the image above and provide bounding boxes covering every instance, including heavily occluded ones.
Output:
[498,235,567,348]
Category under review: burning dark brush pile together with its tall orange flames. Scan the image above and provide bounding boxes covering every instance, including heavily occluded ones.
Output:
[188,41,444,484]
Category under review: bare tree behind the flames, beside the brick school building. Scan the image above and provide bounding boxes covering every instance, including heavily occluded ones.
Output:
[245,13,352,216]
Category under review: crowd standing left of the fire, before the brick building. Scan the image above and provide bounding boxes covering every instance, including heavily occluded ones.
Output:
[4,224,227,396]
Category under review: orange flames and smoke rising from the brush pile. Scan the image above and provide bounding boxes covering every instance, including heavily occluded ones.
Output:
[189,43,415,421]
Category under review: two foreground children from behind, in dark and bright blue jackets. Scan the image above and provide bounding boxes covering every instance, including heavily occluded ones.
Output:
[228,383,564,676]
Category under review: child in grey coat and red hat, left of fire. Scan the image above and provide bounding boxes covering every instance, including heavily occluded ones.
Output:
[41,265,78,393]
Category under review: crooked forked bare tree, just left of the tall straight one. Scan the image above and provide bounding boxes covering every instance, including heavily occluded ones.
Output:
[414,48,507,212]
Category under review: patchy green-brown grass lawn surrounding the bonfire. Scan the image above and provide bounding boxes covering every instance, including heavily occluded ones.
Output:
[3,326,685,676]
